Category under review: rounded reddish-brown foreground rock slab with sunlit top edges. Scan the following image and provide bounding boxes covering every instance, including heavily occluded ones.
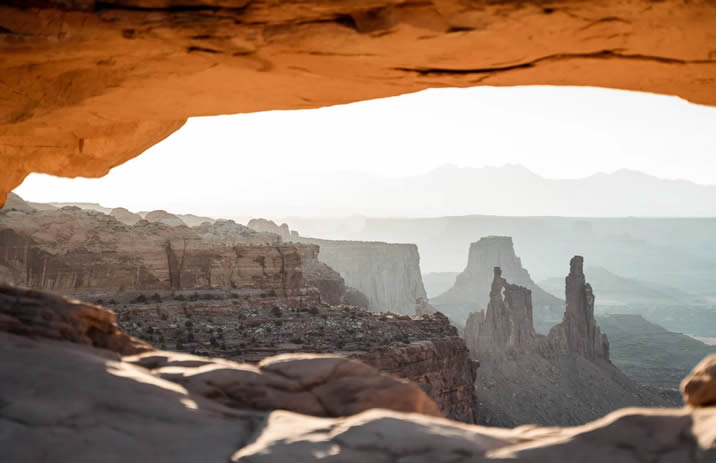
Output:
[125,351,441,417]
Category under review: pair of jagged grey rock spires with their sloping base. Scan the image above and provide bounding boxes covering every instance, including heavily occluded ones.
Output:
[464,256,680,426]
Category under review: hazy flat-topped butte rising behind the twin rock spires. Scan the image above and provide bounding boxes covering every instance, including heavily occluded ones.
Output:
[430,236,564,332]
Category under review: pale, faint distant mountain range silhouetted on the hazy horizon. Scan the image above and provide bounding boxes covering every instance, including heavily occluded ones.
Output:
[266,165,716,217]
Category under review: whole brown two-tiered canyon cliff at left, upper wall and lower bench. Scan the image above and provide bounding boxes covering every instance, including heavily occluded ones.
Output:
[0,195,476,423]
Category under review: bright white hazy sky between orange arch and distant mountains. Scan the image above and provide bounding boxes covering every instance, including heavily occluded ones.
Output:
[16,87,716,217]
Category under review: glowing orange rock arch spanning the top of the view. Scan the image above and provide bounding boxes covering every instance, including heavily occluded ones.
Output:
[0,0,716,205]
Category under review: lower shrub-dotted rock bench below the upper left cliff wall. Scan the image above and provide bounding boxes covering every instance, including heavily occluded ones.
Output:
[113,298,476,423]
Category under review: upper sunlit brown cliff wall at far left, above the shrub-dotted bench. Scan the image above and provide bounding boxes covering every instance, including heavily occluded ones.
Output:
[0,207,314,297]
